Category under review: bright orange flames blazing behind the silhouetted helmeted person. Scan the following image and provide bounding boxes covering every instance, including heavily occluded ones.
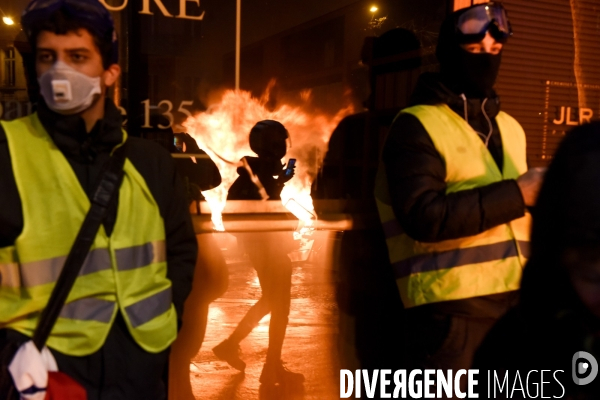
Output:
[183,80,353,230]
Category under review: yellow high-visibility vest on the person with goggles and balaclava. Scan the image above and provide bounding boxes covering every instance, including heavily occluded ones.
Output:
[375,105,531,308]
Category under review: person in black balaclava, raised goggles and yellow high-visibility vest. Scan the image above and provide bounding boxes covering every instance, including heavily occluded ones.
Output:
[375,2,543,388]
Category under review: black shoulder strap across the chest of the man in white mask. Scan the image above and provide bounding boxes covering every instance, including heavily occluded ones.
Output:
[33,142,127,350]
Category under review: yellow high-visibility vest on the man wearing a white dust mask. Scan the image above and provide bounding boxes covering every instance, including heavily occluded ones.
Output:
[0,114,177,356]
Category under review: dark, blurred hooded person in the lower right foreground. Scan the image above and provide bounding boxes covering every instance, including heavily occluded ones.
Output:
[474,123,600,399]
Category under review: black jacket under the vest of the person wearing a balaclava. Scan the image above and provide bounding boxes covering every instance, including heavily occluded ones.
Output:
[382,73,525,317]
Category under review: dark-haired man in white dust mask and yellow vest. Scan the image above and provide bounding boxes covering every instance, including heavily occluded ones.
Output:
[0,0,197,400]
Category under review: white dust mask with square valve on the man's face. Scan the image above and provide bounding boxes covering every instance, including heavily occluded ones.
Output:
[38,61,102,115]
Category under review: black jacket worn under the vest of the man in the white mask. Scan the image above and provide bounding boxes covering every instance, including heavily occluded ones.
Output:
[0,100,198,320]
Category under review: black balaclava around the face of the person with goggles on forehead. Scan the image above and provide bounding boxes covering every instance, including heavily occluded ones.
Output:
[436,8,502,98]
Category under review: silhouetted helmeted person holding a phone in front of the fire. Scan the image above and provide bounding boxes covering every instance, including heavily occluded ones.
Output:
[213,120,304,385]
